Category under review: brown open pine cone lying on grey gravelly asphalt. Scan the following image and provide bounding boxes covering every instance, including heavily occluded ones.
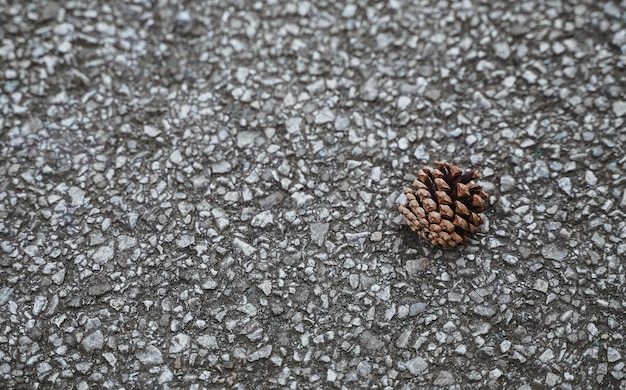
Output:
[398,161,489,247]
